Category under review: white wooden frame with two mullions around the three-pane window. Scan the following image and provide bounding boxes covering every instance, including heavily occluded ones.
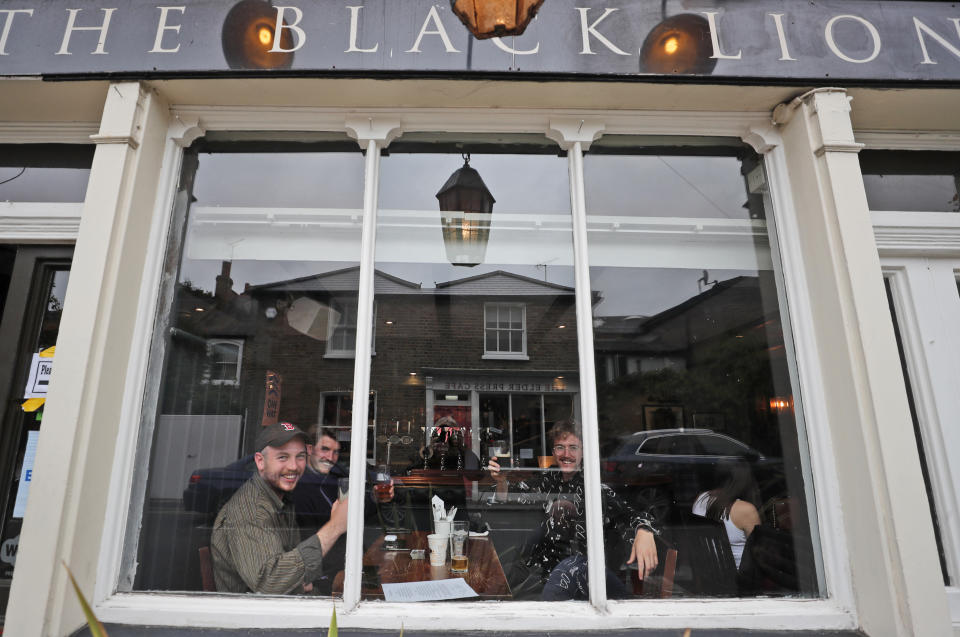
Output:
[93,105,857,631]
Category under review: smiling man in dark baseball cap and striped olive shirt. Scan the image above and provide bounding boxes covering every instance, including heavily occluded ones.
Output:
[210,422,347,594]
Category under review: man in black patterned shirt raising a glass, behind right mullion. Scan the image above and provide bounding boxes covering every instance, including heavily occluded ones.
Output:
[487,420,657,600]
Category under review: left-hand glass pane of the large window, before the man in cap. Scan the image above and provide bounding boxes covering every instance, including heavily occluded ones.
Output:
[127,142,364,595]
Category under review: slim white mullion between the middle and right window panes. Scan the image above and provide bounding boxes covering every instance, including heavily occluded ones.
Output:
[567,141,607,612]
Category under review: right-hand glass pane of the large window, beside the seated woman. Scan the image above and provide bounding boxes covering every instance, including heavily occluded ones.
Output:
[585,138,818,597]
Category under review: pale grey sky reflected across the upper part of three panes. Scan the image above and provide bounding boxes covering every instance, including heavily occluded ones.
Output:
[180,152,757,316]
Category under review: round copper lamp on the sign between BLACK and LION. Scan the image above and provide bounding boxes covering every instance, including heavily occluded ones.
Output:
[640,13,717,75]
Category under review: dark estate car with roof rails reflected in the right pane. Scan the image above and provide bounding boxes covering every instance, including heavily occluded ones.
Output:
[600,429,784,520]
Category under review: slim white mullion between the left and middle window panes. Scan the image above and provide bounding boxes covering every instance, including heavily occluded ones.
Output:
[343,139,380,612]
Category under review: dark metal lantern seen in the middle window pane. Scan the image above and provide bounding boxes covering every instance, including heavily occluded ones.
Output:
[437,153,496,267]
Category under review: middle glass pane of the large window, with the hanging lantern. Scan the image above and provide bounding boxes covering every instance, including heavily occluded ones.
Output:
[363,139,604,599]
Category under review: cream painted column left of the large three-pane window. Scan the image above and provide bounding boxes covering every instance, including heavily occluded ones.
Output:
[4,82,167,635]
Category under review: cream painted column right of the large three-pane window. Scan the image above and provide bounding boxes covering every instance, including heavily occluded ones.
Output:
[774,89,951,637]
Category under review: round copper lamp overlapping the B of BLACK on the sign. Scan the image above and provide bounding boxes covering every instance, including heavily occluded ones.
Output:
[220,0,294,69]
